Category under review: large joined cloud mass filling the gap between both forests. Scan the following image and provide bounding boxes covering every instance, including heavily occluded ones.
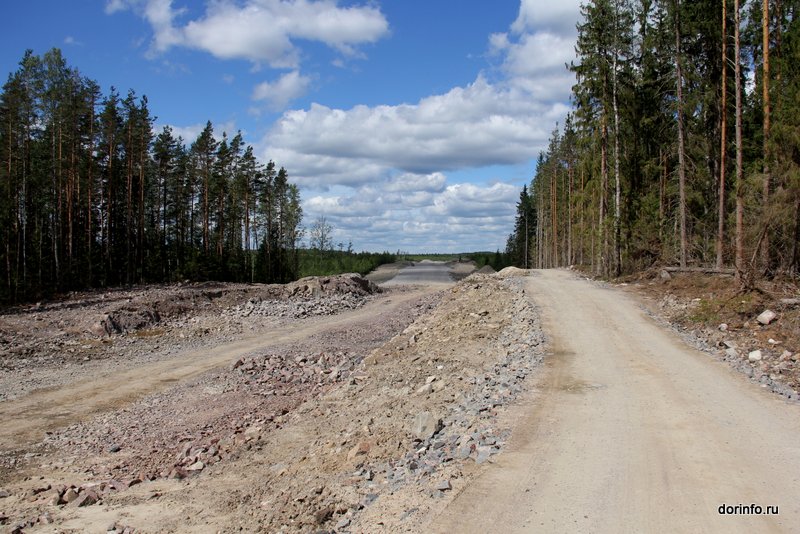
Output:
[262,0,579,252]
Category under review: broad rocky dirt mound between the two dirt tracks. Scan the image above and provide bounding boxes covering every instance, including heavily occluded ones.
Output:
[0,274,544,532]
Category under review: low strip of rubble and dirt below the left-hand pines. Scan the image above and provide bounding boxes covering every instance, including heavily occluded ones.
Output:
[0,274,382,400]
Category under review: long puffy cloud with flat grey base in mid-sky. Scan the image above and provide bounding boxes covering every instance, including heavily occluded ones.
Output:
[265,76,563,185]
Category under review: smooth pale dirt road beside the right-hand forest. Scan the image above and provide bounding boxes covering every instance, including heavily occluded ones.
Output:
[432,271,800,533]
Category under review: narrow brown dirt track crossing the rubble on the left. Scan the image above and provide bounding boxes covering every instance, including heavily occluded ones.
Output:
[0,288,434,451]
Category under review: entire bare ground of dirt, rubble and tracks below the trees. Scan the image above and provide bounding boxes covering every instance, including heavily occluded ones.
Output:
[0,265,800,533]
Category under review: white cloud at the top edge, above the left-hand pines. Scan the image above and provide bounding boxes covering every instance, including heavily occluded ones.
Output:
[106,0,389,68]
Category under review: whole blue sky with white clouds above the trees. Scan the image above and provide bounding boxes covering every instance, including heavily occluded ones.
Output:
[0,0,580,252]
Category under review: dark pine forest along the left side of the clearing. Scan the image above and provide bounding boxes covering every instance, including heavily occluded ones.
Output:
[0,49,302,302]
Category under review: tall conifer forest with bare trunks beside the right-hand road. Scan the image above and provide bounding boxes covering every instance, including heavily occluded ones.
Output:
[506,0,800,283]
